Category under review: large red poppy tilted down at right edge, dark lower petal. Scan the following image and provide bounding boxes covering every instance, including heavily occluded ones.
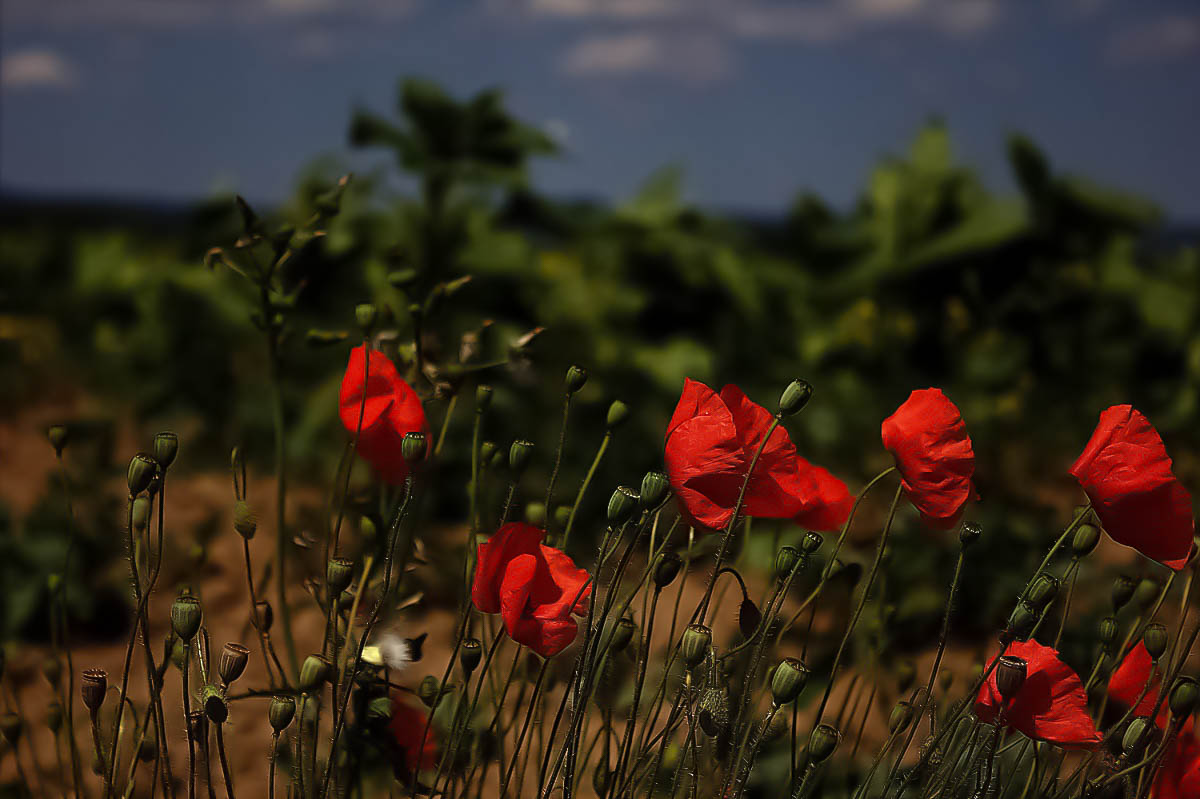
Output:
[1070,405,1193,570]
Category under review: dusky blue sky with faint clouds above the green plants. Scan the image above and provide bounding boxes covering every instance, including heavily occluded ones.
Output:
[0,0,1200,221]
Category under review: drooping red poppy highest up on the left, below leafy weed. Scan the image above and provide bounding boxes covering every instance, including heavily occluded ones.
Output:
[338,344,430,486]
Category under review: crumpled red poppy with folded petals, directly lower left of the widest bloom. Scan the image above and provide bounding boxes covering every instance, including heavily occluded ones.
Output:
[470,522,592,657]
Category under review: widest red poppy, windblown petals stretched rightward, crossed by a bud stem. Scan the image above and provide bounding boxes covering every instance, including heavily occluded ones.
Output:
[666,379,854,530]
